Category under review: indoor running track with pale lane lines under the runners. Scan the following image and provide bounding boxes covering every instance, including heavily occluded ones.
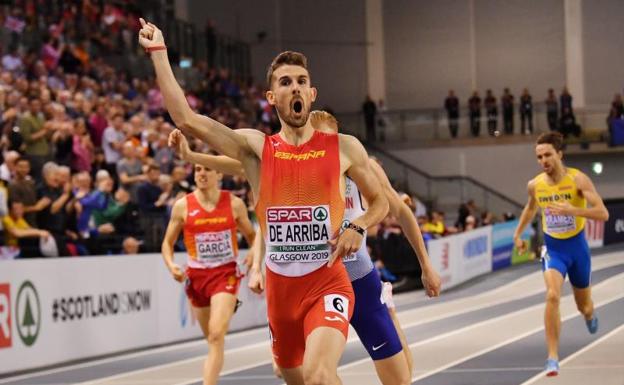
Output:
[0,251,624,385]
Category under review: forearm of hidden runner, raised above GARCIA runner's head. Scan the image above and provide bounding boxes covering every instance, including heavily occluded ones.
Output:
[169,130,245,177]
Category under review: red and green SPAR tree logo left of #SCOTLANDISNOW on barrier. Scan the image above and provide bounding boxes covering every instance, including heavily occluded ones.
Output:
[0,281,41,349]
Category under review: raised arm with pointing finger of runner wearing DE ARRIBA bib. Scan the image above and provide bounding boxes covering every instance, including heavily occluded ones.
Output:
[139,19,263,160]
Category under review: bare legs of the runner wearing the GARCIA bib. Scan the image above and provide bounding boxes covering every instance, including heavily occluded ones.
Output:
[195,293,236,385]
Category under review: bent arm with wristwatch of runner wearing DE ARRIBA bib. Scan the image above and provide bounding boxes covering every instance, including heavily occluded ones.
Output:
[327,135,388,267]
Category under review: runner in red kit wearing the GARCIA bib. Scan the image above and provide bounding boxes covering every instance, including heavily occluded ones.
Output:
[162,165,255,385]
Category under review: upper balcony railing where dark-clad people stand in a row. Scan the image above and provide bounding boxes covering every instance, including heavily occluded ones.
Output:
[337,103,609,143]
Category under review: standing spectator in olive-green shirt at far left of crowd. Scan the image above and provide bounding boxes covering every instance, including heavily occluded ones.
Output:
[18,98,50,179]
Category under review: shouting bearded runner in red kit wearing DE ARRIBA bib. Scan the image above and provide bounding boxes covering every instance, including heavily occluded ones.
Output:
[139,19,388,385]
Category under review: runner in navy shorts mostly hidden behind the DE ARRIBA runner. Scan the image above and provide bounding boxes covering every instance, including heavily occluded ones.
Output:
[169,111,440,385]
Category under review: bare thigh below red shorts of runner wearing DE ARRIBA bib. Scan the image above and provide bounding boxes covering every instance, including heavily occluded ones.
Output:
[302,321,346,385]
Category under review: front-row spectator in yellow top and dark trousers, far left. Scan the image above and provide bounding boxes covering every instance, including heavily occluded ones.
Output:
[2,201,51,258]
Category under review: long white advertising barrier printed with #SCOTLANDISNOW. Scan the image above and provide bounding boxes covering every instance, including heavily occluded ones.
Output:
[0,251,266,374]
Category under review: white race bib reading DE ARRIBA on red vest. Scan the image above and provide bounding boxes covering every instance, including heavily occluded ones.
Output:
[266,205,331,263]
